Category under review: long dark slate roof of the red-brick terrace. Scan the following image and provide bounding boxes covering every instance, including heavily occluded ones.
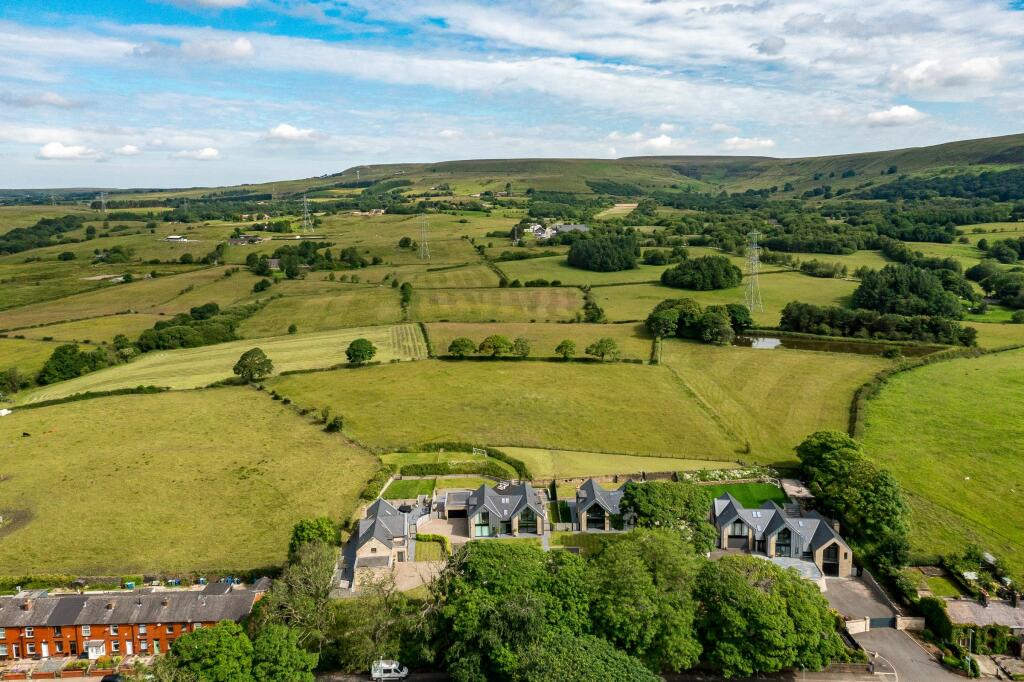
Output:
[0,587,262,628]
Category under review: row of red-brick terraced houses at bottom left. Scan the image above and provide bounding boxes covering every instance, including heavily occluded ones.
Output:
[0,580,269,660]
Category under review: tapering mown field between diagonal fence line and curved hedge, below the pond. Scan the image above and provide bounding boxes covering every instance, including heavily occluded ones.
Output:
[662,339,891,463]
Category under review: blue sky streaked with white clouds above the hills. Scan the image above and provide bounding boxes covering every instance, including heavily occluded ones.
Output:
[0,0,1024,187]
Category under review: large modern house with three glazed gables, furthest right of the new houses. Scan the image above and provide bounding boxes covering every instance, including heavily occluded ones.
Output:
[711,493,853,578]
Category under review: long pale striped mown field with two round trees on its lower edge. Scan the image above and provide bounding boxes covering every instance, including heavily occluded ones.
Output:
[17,325,426,403]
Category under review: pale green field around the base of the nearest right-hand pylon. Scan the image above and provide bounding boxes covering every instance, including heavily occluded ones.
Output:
[594,271,857,327]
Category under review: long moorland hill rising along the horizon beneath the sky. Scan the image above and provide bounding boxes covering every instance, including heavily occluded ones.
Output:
[97,134,1024,199]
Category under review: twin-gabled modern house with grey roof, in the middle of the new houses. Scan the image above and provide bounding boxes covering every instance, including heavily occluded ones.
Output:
[466,481,547,538]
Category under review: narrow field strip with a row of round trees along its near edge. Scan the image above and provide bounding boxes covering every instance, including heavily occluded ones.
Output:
[427,323,653,361]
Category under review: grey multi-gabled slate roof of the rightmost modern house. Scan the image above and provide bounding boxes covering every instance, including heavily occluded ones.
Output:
[712,493,847,553]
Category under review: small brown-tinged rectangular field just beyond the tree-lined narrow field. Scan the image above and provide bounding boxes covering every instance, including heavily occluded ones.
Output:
[412,287,583,322]
